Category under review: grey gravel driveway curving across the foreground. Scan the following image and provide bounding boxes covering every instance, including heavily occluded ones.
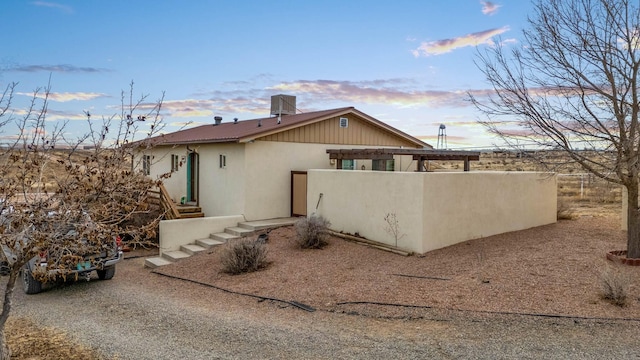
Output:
[12,258,640,359]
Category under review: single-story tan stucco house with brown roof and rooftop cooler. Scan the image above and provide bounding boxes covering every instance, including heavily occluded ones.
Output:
[137,95,432,220]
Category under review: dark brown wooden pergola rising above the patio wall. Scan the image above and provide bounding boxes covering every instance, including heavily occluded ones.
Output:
[327,149,480,172]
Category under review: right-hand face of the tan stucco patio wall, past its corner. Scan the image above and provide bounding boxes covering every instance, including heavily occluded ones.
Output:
[422,172,557,251]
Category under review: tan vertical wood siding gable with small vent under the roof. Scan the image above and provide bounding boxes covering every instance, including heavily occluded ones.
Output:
[256,113,417,148]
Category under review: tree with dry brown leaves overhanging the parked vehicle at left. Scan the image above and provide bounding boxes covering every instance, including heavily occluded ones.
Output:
[0,79,168,359]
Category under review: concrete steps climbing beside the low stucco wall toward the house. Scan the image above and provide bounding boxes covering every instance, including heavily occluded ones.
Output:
[144,218,297,269]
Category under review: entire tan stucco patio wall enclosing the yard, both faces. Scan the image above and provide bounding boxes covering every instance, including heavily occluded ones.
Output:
[307,170,557,253]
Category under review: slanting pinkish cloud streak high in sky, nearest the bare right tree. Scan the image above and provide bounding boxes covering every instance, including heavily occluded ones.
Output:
[411,26,509,57]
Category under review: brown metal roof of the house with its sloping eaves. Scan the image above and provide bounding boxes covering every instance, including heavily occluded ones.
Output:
[140,107,431,147]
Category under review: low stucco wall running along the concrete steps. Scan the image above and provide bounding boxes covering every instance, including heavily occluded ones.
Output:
[160,215,244,255]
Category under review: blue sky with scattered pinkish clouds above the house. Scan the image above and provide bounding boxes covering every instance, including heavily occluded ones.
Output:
[0,0,532,149]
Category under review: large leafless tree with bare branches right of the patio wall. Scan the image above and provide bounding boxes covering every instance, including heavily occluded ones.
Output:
[469,0,640,258]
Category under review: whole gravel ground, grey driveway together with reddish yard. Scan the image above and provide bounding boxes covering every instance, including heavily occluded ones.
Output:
[7,215,640,359]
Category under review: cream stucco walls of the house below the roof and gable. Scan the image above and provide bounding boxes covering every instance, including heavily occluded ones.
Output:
[146,141,416,220]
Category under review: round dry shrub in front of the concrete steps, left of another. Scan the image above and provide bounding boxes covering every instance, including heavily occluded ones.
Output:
[220,238,269,275]
